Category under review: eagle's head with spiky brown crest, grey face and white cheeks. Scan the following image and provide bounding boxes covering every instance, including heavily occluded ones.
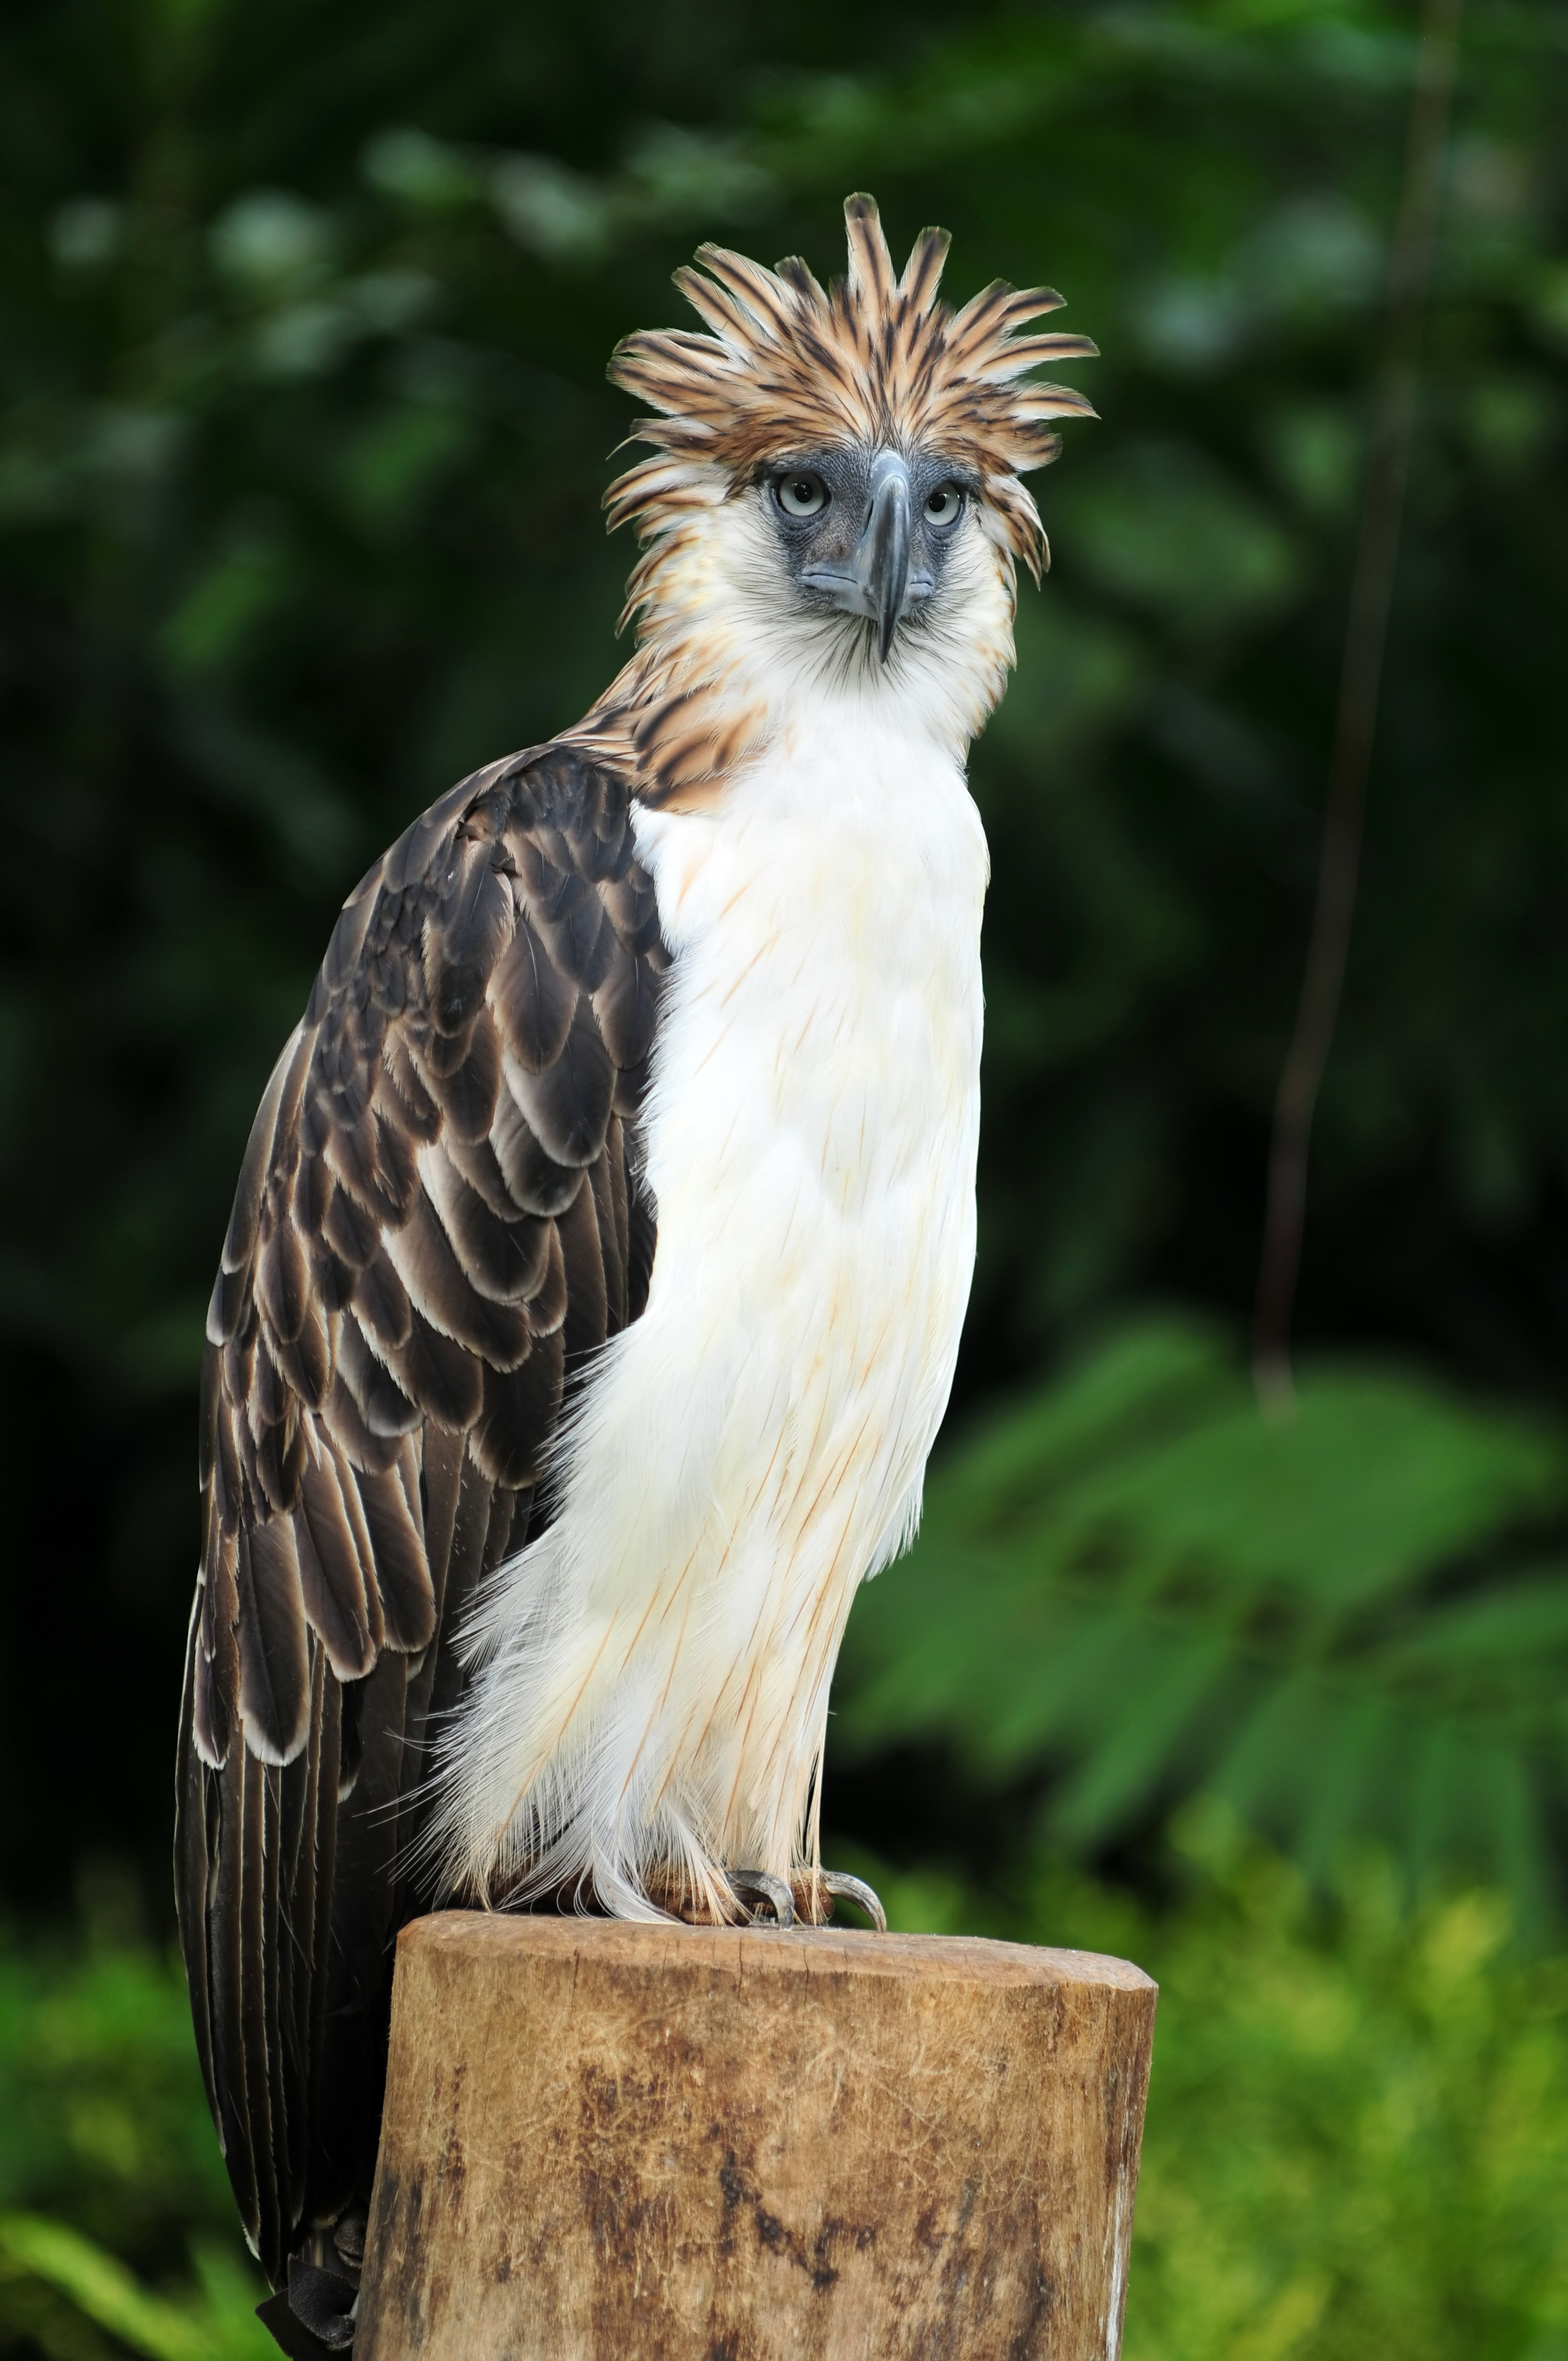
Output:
[595,196,1096,801]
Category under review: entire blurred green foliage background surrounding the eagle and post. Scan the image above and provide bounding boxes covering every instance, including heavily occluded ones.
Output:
[0,0,1568,2361]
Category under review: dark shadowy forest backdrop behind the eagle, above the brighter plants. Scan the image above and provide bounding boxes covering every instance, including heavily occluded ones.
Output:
[0,0,1568,1915]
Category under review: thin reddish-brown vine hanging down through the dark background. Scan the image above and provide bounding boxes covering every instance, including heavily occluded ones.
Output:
[1251,0,1464,1410]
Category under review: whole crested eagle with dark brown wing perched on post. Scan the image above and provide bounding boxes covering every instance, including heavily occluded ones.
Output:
[177,196,1093,2352]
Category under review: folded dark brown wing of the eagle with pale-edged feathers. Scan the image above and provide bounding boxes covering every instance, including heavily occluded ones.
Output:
[175,741,668,2286]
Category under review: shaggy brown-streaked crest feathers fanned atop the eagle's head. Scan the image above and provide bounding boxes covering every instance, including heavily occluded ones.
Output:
[607,196,1096,579]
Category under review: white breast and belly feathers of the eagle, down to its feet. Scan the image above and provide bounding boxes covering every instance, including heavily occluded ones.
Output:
[442,701,987,1917]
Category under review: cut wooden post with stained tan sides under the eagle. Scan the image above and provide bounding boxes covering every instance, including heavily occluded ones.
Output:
[354,1912,1155,2361]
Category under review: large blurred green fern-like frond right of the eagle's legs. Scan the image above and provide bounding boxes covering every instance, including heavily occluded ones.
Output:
[831,1318,1568,1941]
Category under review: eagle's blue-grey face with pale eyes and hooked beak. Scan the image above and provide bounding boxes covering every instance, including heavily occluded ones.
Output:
[763,444,980,663]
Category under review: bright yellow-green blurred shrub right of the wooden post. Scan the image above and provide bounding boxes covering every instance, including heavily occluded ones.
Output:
[862,1797,1568,2361]
